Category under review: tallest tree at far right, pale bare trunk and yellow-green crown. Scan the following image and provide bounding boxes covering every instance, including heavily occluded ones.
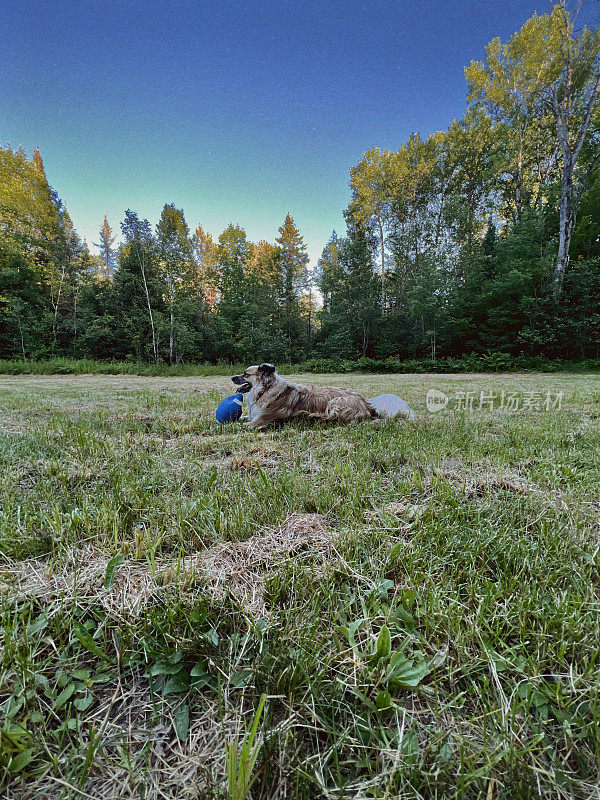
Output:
[466,3,600,302]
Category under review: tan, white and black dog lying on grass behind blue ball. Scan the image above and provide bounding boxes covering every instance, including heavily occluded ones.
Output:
[231,364,377,428]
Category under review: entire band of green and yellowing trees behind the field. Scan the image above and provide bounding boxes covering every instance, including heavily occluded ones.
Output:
[0,3,600,364]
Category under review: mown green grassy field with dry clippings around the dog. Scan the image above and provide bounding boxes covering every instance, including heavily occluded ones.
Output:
[0,374,600,800]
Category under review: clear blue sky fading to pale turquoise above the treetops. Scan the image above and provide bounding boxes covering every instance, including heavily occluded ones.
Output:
[0,0,584,265]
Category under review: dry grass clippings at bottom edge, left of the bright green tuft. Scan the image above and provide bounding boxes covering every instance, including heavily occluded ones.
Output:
[4,674,243,800]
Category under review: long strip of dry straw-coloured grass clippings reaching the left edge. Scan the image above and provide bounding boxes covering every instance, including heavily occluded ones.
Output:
[0,514,334,618]
